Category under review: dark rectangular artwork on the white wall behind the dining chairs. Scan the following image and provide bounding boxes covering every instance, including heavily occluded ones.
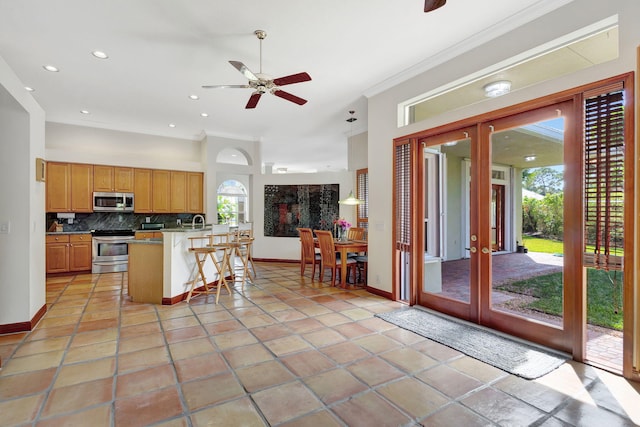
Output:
[264,184,340,237]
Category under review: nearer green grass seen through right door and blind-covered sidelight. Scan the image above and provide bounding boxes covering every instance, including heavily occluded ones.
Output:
[496,268,622,331]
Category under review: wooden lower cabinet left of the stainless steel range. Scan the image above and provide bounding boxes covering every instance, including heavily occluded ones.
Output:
[46,234,91,273]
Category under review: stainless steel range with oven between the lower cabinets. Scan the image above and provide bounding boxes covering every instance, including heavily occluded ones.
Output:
[91,230,135,273]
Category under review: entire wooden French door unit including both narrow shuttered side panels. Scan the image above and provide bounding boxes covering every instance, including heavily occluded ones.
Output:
[393,73,640,374]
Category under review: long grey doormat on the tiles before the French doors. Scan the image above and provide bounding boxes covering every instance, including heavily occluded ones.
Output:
[376,308,569,380]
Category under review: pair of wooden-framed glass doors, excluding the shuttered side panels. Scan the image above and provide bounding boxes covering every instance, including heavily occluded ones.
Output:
[417,102,581,352]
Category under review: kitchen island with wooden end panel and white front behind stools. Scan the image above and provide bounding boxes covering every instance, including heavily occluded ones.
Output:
[129,225,228,305]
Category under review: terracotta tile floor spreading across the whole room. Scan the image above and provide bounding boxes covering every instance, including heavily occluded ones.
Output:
[0,263,640,427]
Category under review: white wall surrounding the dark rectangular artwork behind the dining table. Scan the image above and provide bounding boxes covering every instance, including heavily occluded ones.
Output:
[252,172,356,260]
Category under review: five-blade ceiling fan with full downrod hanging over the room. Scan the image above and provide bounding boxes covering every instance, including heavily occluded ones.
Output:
[202,30,311,108]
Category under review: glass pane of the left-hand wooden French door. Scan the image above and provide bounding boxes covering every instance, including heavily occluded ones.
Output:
[418,129,477,319]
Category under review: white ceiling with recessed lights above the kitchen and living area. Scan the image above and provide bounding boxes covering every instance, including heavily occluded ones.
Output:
[0,0,570,172]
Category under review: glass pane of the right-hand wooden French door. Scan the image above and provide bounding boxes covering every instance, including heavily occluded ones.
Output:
[481,113,565,344]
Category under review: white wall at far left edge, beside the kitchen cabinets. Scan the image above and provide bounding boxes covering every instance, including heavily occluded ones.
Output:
[0,58,46,325]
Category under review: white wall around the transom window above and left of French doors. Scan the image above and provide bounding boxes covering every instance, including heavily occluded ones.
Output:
[368,0,640,291]
